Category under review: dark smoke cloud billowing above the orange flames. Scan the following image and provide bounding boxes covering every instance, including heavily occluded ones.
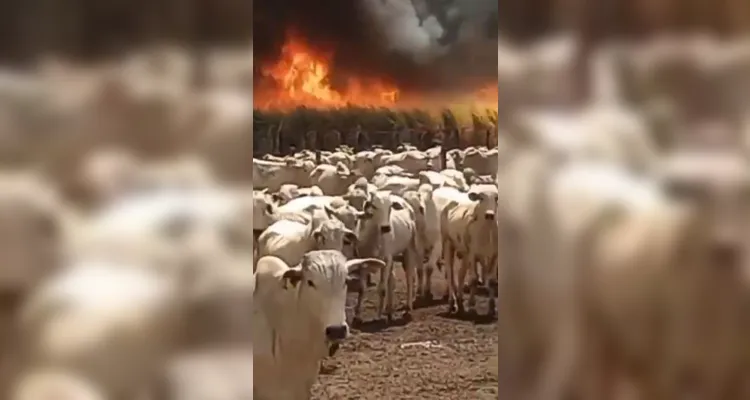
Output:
[253,0,498,93]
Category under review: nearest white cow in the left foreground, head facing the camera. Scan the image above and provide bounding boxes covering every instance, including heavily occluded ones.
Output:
[252,250,384,400]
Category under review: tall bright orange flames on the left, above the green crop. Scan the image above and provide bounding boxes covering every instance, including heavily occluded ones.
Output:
[255,34,399,109]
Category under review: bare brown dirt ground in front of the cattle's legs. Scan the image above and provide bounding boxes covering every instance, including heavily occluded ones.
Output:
[313,268,497,400]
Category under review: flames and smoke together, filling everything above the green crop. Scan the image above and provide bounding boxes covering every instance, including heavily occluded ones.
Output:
[253,0,497,110]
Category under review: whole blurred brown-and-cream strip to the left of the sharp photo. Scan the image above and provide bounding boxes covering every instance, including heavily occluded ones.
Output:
[0,0,253,400]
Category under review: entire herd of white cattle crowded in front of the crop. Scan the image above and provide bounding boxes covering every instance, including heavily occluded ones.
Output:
[253,144,498,399]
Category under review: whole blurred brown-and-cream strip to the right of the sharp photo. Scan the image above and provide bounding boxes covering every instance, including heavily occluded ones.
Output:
[498,0,750,399]
